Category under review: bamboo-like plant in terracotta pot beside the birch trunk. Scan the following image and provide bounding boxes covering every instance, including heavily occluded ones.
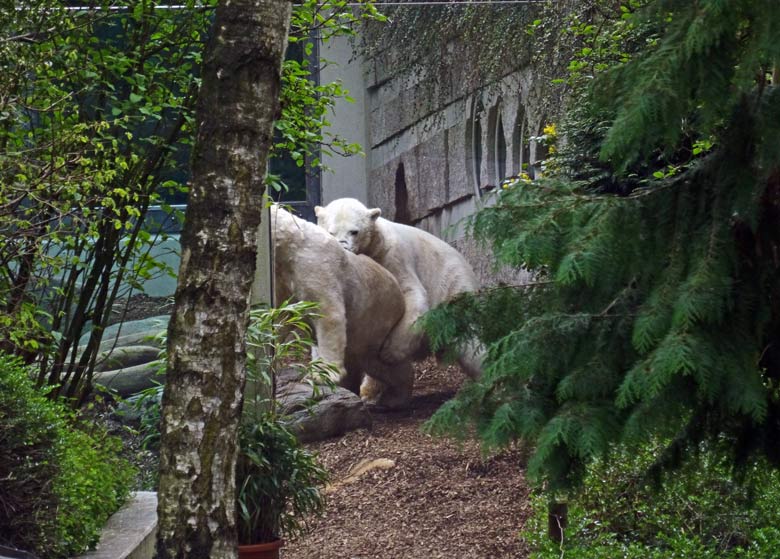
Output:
[236,303,336,559]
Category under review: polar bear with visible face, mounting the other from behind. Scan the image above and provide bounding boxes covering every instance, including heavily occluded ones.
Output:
[314,198,481,377]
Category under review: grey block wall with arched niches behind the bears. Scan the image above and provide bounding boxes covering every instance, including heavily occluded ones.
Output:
[336,34,546,284]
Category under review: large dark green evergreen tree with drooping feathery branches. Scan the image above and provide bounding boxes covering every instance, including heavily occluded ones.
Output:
[425,0,780,490]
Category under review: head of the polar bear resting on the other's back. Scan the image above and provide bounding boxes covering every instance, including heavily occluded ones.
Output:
[314,198,382,254]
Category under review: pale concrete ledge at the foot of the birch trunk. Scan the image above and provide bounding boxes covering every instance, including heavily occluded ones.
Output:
[73,491,157,559]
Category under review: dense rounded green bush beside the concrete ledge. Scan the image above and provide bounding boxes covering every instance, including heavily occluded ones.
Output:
[0,353,133,558]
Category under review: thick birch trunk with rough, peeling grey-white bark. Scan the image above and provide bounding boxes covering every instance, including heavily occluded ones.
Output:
[157,0,290,559]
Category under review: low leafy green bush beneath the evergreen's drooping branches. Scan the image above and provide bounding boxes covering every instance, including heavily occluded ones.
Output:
[524,445,780,559]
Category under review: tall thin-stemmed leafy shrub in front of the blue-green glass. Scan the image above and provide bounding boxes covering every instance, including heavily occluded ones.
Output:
[0,0,209,404]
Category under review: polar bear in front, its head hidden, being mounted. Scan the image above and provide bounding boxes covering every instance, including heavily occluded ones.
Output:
[271,205,413,407]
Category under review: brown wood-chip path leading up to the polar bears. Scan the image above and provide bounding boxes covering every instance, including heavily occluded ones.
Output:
[283,361,529,559]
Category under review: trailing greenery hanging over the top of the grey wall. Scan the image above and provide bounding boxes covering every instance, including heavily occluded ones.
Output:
[360,0,593,118]
